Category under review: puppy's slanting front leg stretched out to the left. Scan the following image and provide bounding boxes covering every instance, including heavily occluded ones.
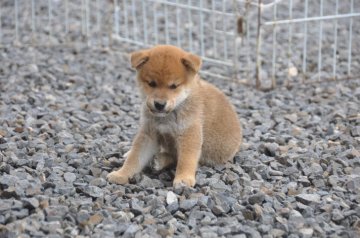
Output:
[107,131,158,184]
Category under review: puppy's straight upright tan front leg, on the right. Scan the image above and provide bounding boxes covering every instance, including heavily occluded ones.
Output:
[173,125,202,187]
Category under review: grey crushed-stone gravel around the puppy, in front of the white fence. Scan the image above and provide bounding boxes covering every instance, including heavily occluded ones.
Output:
[0,47,360,237]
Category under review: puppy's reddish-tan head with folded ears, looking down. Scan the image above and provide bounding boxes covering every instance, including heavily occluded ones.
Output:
[131,45,201,117]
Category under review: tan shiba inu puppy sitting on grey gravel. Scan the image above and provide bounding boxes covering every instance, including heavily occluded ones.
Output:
[107,45,242,186]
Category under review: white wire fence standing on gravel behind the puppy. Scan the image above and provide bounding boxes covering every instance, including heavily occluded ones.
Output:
[0,0,360,88]
